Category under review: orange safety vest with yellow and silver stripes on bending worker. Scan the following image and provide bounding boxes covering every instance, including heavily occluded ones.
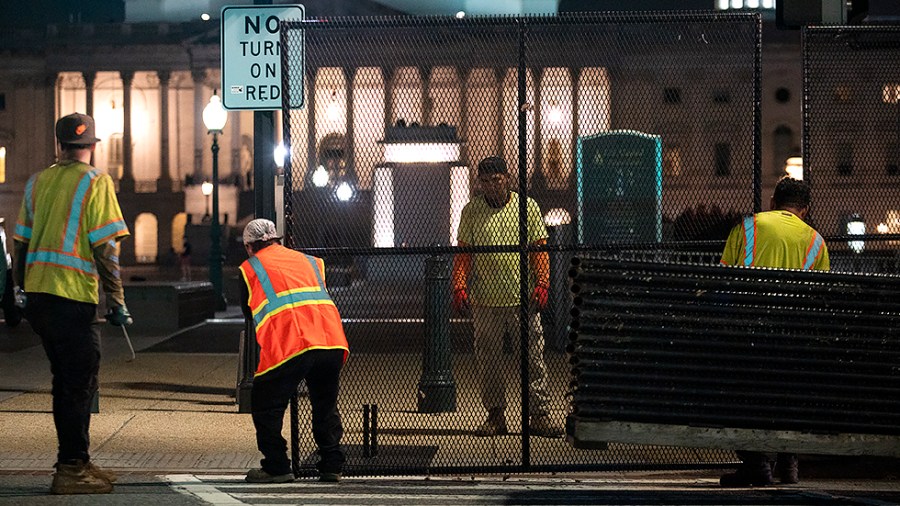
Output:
[240,244,350,376]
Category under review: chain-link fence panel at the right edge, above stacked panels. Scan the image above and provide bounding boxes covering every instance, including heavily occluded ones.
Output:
[803,26,900,273]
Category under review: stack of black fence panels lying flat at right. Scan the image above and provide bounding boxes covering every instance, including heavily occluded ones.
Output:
[572,258,900,436]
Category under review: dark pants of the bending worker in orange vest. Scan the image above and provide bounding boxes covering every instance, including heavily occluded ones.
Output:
[250,350,344,475]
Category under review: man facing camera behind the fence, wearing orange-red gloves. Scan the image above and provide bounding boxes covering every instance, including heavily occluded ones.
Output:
[453,156,562,437]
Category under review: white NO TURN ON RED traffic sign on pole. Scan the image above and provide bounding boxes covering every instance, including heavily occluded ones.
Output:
[220,5,305,111]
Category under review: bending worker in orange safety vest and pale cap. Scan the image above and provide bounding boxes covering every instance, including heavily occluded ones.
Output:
[240,219,350,483]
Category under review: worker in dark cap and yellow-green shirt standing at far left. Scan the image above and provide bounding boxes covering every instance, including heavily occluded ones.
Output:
[13,113,131,494]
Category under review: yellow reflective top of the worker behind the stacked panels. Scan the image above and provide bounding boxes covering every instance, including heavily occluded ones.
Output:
[722,210,831,271]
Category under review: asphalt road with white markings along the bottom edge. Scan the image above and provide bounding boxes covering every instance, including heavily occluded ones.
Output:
[0,474,900,506]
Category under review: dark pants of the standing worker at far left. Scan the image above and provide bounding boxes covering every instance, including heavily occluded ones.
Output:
[26,293,100,463]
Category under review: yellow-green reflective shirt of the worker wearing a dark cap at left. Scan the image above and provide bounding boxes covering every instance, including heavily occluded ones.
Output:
[13,160,129,304]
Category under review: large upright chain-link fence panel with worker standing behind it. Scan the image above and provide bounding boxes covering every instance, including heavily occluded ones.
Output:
[282,13,760,473]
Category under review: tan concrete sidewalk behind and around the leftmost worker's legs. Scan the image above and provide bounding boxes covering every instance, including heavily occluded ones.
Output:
[0,308,259,472]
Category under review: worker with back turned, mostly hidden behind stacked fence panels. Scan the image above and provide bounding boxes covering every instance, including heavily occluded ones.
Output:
[720,177,830,487]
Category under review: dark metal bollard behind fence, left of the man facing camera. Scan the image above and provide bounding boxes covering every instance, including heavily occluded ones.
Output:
[418,256,456,413]
